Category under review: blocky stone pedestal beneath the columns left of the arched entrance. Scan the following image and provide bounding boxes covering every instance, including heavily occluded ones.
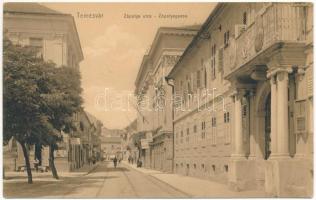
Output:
[228,155,256,191]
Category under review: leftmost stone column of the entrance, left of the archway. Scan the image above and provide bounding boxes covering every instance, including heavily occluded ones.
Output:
[232,91,245,158]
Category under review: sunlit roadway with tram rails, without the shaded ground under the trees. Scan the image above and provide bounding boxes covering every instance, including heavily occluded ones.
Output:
[64,162,186,198]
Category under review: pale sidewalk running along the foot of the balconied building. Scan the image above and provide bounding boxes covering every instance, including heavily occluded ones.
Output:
[123,161,267,198]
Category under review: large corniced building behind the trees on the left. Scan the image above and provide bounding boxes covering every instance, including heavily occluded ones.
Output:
[3,3,83,172]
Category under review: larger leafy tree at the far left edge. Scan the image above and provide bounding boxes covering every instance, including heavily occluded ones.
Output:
[3,38,53,183]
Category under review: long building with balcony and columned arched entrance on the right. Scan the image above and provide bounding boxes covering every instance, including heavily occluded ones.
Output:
[168,3,313,196]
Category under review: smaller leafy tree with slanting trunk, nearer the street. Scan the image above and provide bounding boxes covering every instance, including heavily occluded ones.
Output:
[42,66,83,179]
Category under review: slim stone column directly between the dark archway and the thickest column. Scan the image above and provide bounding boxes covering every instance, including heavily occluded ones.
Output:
[270,76,278,157]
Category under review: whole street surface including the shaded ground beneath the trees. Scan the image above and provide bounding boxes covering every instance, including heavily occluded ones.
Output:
[4,162,187,198]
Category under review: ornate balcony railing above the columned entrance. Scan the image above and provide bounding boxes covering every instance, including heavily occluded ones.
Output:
[223,3,306,76]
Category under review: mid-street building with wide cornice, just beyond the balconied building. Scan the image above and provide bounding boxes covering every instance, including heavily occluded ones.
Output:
[135,26,199,172]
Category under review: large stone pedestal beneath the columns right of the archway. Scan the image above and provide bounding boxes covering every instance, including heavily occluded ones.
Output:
[265,157,313,197]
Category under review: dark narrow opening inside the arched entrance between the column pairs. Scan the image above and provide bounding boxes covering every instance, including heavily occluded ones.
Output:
[264,93,271,160]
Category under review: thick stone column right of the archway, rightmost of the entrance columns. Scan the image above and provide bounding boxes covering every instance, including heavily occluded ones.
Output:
[272,70,289,157]
